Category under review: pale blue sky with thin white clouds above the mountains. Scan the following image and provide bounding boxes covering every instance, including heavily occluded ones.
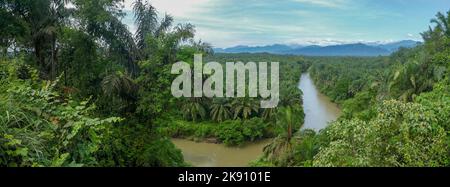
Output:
[119,0,450,47]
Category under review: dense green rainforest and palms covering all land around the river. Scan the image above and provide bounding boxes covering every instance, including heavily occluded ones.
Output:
[0,0,450,167]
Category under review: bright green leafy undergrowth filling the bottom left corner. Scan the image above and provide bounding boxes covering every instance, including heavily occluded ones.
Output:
[0,64,122,166]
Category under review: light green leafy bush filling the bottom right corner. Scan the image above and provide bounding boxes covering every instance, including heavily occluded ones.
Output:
[314,101,448,167]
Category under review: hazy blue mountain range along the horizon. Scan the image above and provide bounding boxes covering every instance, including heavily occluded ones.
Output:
[214,40,420,56]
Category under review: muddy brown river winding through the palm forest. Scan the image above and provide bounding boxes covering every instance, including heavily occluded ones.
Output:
[172,73,340,167]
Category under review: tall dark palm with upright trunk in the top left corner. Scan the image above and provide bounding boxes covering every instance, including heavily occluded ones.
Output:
[8,0,73,79]
